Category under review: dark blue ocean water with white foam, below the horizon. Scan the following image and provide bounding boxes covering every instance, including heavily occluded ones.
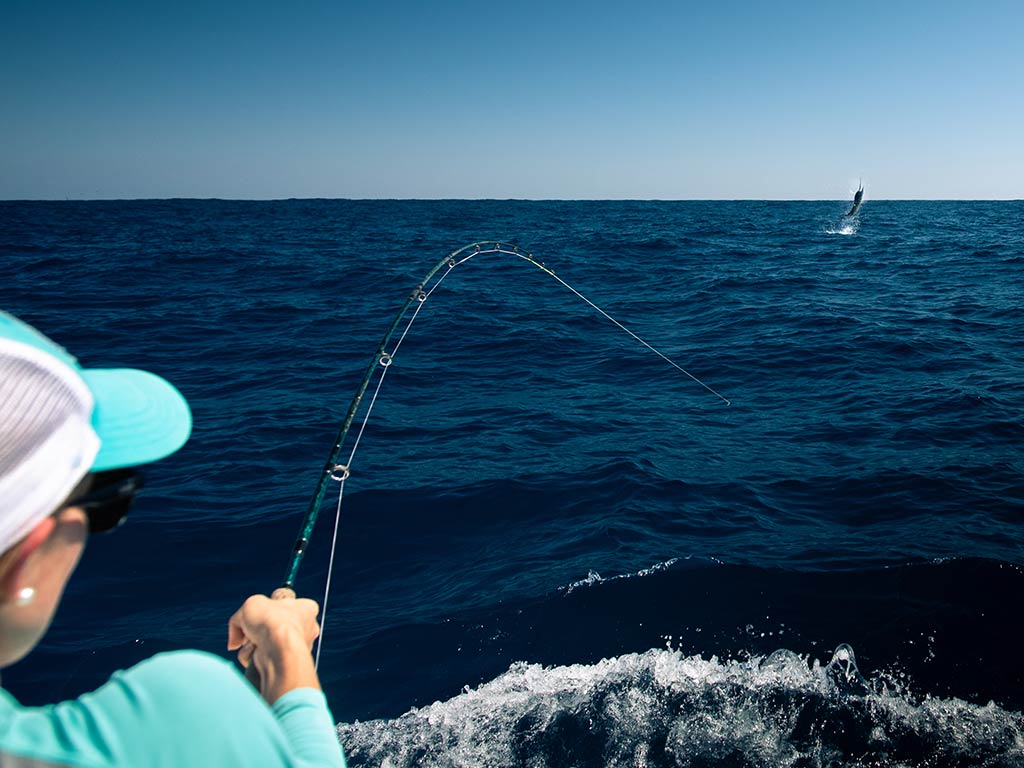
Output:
[0,200,1024,766]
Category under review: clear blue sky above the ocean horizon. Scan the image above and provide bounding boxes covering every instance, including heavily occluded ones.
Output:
[0,0,1024,200]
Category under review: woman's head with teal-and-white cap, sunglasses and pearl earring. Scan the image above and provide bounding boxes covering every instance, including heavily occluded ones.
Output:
[0,311,191,667]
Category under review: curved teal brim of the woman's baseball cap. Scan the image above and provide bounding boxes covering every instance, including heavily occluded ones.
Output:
[79,368,191,472]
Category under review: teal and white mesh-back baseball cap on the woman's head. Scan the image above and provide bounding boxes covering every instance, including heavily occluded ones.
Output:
[0,311,191,553]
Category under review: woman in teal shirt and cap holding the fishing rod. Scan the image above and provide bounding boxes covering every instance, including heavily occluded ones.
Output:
[0,312,345,768]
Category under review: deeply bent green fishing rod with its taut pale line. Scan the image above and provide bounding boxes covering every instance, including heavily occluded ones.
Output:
[282,243,730,666]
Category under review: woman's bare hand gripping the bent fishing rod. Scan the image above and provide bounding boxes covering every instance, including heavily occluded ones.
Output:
[227,590,321,705]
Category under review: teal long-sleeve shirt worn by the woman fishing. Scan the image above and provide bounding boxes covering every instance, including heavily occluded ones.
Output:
[0,651,345,768]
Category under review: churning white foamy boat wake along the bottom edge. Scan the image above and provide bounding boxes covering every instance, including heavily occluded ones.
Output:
[338,645,1024,768]
